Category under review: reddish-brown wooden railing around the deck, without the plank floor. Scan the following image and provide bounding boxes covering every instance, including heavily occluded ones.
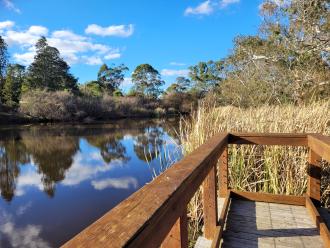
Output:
[63,133,330,247]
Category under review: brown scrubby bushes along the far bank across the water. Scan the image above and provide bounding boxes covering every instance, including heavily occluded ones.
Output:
[17,91,192,122]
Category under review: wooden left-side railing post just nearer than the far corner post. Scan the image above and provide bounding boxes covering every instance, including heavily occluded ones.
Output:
[203,161,218,239]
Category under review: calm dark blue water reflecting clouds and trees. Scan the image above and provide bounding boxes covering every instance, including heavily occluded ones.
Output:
[0,120,180,247]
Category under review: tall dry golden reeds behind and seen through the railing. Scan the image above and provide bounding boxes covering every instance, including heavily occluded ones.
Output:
[180,101,330,244]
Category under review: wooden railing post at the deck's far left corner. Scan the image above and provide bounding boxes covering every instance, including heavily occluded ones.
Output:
[219,145,228,197]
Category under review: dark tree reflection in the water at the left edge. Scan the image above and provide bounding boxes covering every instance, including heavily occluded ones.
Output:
[0,139,29,201]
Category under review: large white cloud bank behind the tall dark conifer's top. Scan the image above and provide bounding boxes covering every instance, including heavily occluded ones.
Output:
[0,21,125,65]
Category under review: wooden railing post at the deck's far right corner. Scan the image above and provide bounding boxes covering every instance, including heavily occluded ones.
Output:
[307,149,321,204]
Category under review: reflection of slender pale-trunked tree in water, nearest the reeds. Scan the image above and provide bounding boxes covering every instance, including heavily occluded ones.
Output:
[134,127,164,162]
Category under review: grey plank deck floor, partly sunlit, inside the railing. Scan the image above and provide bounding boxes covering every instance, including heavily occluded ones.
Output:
[220,199,324,248]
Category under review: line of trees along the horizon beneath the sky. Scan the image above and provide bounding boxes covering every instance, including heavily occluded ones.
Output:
[0,0,330,113]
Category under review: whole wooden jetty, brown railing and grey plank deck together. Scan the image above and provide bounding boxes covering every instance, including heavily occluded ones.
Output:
[63,133,330,248]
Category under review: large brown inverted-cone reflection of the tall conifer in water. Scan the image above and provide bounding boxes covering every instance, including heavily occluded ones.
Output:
[24,136,79,197]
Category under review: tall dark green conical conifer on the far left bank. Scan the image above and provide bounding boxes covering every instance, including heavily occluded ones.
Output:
[27,37,78,93]
